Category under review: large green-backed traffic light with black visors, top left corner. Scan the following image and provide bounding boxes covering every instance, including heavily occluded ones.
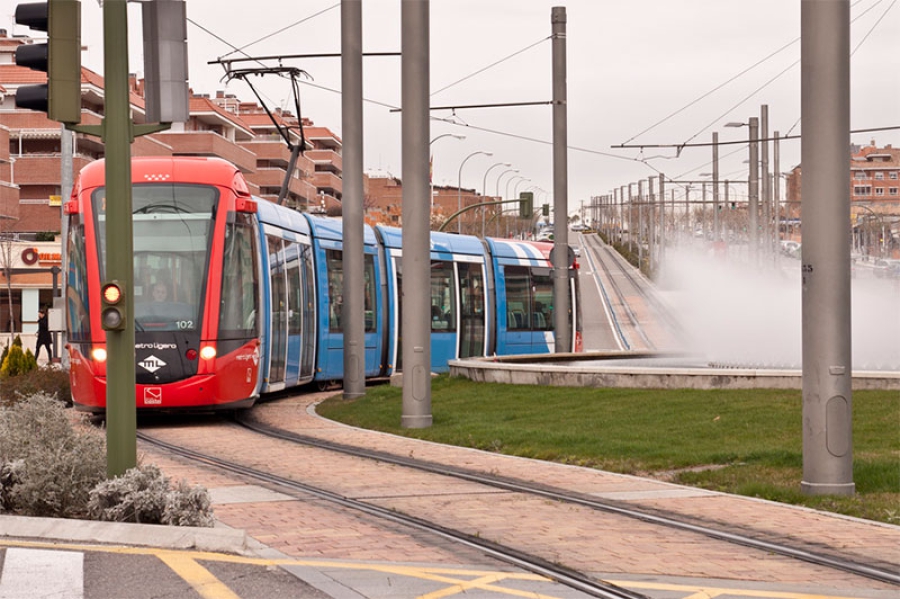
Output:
[16,0,81,123]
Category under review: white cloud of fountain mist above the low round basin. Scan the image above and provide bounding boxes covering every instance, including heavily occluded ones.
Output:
[660,248,900,371]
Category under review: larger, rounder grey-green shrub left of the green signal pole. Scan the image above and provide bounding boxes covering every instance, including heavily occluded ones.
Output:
[0,394,106,518]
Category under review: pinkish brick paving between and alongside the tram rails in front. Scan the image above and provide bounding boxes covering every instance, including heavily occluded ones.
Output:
[139,394,900,590]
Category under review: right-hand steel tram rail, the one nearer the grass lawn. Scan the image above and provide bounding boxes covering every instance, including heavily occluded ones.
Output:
[236,418,900,584]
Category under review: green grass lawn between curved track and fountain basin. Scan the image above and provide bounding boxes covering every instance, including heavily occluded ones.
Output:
[318,376,900,524]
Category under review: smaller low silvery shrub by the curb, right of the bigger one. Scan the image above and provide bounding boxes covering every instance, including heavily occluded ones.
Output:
[88,464,213,526]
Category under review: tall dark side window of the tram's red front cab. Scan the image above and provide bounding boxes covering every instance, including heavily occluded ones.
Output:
[219,214,259,337]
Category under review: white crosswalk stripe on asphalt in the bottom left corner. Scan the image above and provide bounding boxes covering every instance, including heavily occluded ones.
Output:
[0,547,84,599]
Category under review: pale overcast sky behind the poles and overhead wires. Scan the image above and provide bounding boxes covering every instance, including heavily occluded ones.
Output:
[65,0,900,211]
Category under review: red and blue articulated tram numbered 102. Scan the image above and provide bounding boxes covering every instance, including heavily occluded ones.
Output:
[65,157,581,412]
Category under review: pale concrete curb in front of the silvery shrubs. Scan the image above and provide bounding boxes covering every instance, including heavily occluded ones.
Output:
[0,515,251,554]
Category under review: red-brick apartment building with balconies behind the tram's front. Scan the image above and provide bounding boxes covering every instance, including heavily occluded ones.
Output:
[0,29,343,333]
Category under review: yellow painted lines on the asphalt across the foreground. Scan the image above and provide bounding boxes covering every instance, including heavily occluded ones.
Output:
[0,538,880,599]
